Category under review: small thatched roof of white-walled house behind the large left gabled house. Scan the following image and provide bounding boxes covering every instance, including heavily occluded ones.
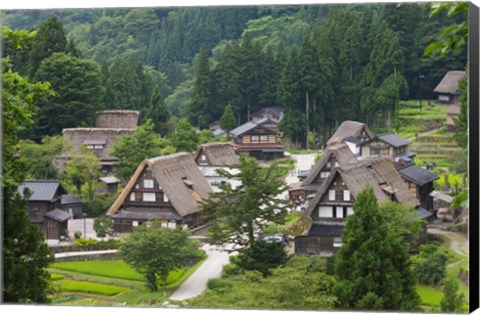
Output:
[194,142,239,166]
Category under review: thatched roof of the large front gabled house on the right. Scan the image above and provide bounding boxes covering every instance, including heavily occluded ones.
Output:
[303,157,419,234]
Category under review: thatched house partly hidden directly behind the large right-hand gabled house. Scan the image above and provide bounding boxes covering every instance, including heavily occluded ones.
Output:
[288,143,357,204]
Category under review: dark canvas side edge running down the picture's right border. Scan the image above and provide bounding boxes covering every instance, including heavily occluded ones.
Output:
[468,2,480,312]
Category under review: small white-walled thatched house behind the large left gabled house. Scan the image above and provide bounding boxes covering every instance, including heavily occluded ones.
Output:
[194,142,241,192]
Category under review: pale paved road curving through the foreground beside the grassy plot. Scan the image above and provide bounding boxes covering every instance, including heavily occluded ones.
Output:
[170,244,231,301]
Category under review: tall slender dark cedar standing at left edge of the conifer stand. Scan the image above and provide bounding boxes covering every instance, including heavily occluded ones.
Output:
[189,46,213,129]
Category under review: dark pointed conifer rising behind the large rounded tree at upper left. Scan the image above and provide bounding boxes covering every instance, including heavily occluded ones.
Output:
[29,15,67,78]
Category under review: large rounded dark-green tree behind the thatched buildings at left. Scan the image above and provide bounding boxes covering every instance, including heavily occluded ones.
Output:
[36,53,104,139]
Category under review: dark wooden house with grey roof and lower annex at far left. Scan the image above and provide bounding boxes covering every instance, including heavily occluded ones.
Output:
[18,180,82,240]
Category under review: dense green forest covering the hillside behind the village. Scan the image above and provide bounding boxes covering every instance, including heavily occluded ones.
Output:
[3,3,467,146]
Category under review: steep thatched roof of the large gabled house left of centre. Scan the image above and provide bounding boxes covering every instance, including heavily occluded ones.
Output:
[108,152,212,216]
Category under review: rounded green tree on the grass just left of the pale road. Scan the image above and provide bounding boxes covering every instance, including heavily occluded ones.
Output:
[120,222,201,291]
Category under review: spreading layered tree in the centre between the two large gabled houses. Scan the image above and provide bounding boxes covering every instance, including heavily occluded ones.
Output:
[202,156,287,248]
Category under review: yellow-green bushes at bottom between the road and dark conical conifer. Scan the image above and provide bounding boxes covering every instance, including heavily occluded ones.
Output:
[185,256,335,310]
